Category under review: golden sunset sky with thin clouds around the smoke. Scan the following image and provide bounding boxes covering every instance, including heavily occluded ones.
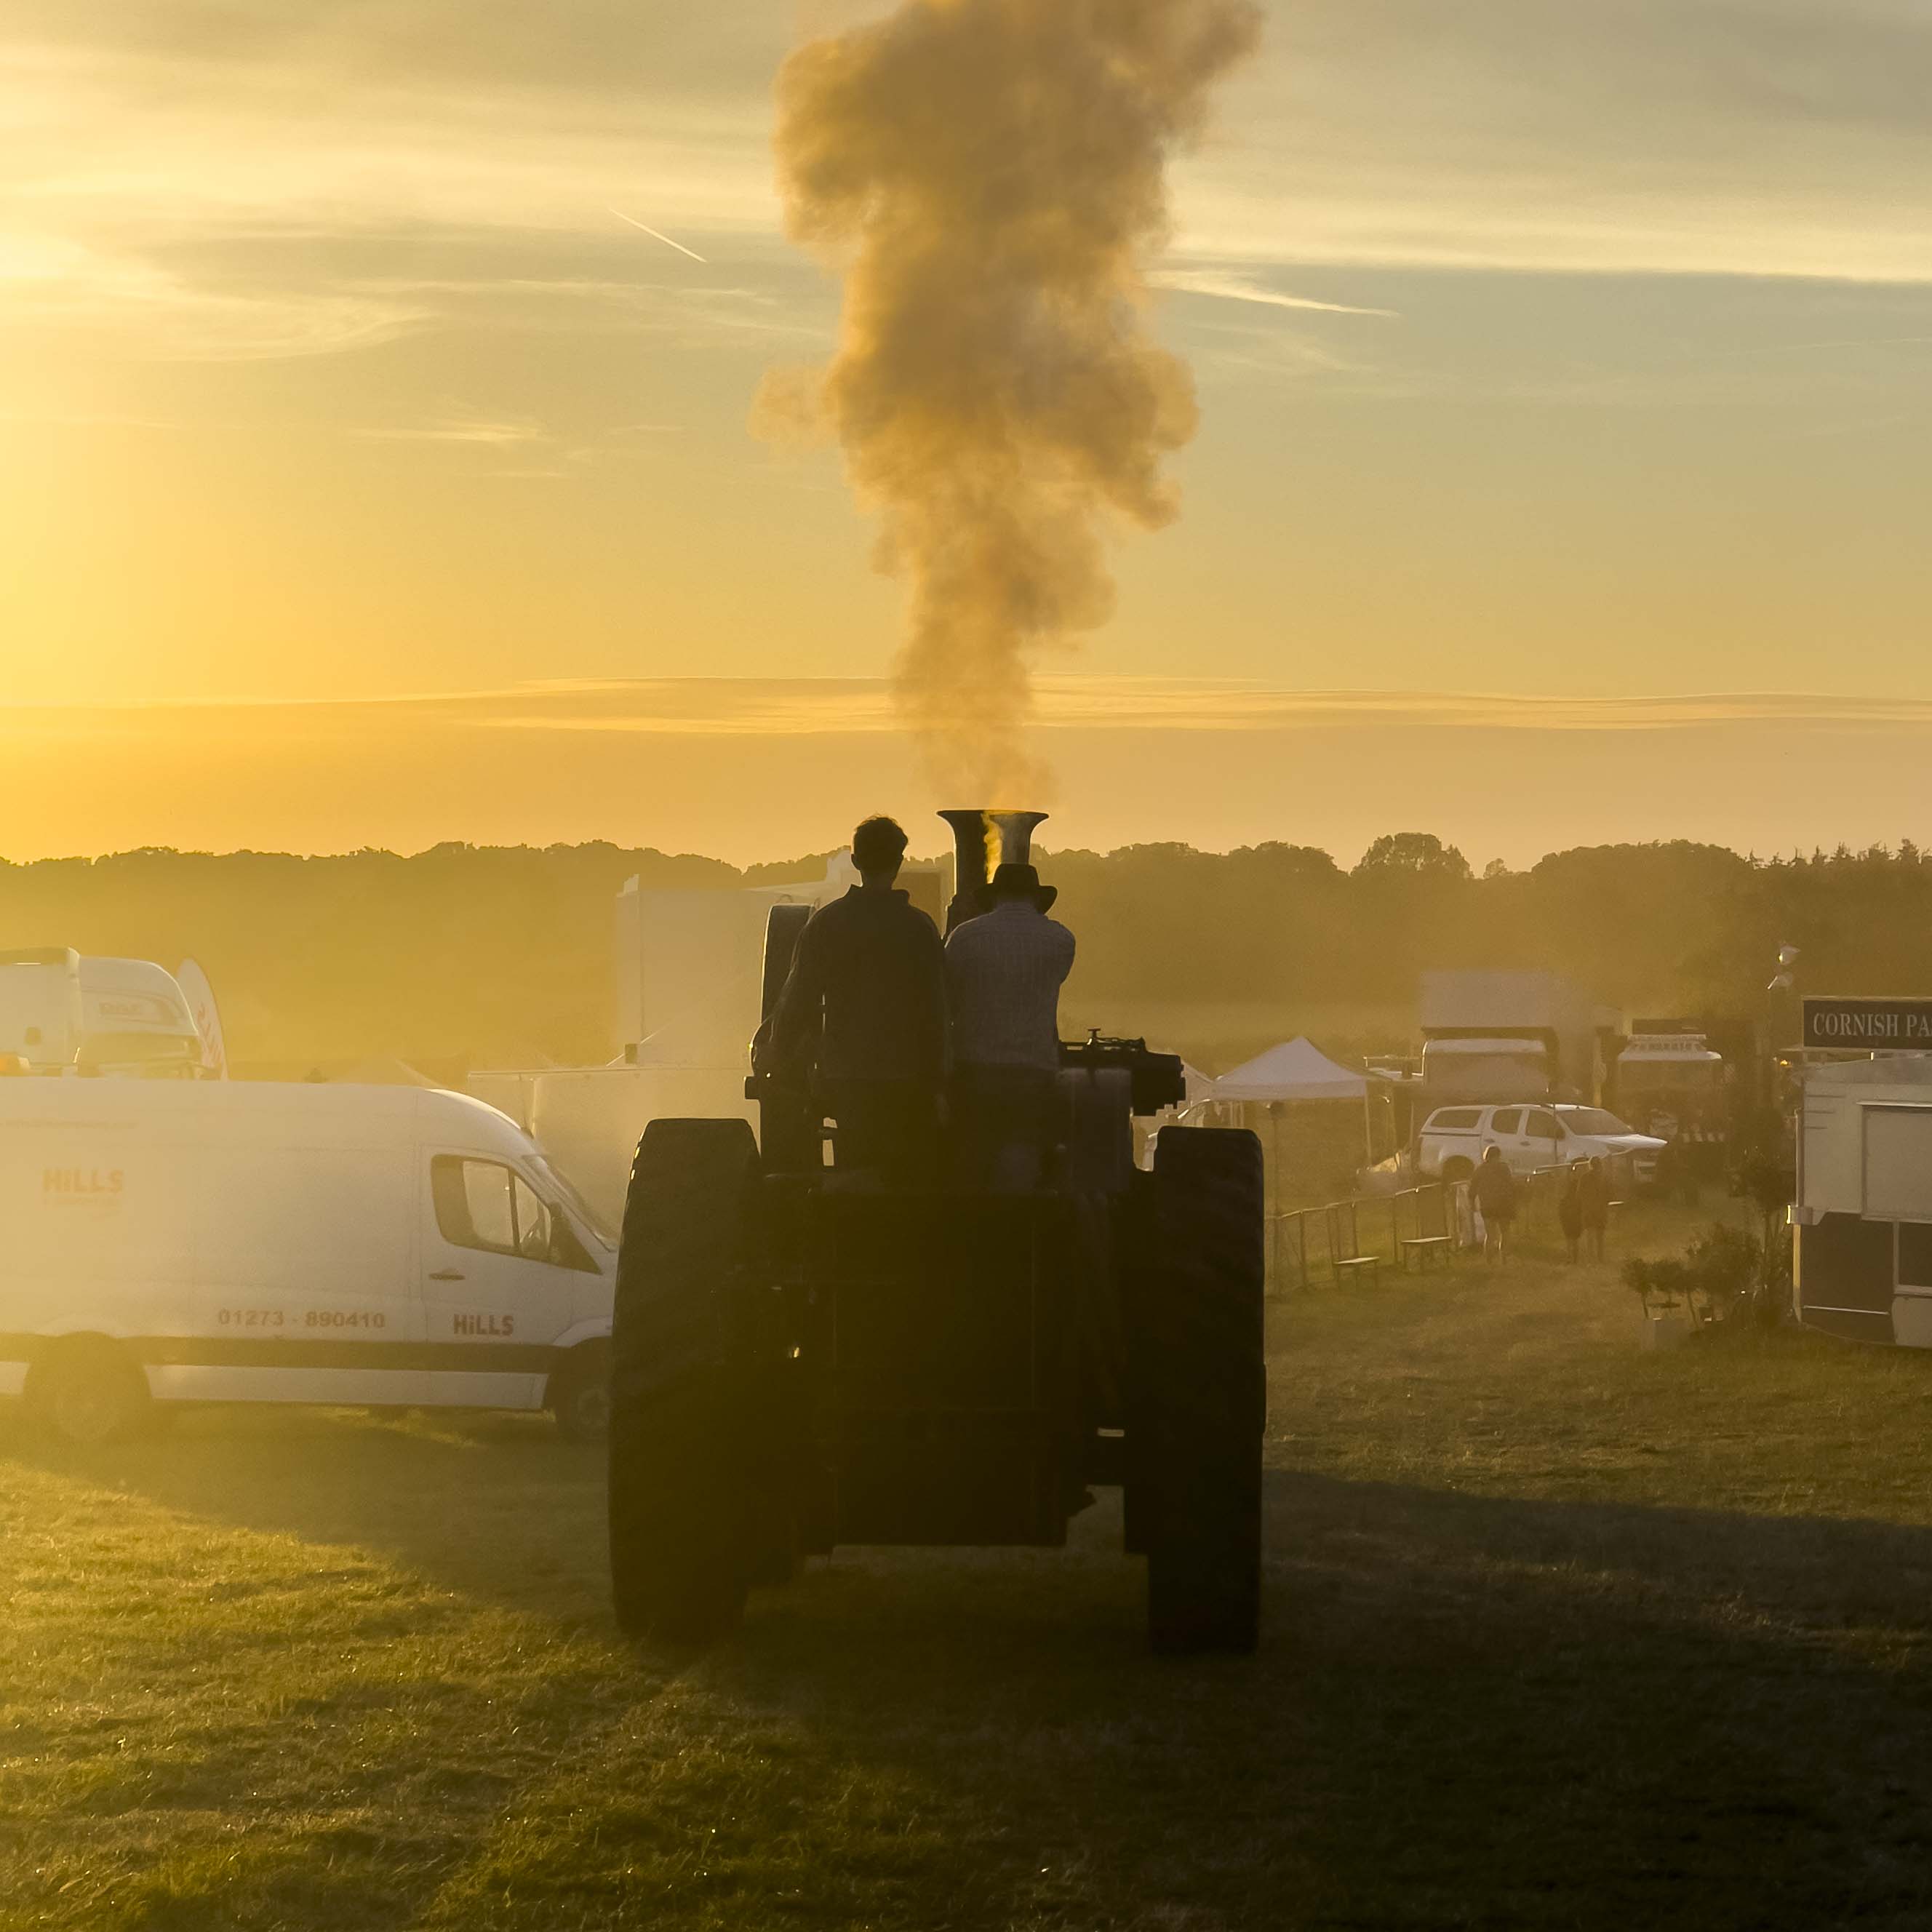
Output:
[0,0,1932,860]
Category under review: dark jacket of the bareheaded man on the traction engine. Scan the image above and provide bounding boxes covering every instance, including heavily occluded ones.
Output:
[761,885,946,1090]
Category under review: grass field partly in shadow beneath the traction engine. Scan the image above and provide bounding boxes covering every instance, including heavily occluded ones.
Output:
[0,1216,1932,1932]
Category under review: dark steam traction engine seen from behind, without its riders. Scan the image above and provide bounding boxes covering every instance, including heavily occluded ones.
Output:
[610,812,1266,1652]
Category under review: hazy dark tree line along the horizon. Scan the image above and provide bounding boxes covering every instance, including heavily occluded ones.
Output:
[0,833,1932,1078]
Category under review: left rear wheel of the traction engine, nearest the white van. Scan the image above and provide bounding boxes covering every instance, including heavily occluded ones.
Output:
[609,1120,761,1644]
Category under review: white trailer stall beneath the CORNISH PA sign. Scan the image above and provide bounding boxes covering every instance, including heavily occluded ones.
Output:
[1791,1055,1932,1349]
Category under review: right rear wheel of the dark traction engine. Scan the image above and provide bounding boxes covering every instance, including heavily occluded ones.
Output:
[1130,1126,1267,1654]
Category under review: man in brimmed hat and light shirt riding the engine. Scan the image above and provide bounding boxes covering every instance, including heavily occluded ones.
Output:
[946,866,1074,1192]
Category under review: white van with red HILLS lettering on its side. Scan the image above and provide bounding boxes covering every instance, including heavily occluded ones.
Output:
[0,1080,616,1441]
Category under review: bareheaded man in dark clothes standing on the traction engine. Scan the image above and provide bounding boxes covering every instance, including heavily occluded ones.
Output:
[759,819,946,1186]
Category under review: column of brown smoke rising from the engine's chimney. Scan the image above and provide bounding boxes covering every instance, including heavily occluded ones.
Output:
[761,0,1258,802]
